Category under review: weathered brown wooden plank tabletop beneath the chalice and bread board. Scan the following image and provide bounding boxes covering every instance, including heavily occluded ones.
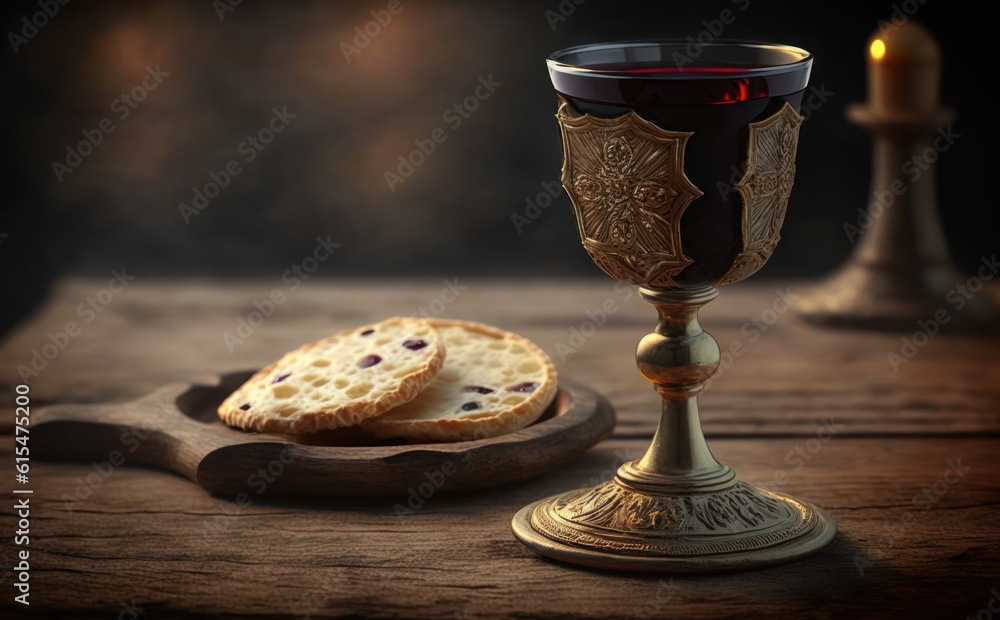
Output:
[0,278,1000,618]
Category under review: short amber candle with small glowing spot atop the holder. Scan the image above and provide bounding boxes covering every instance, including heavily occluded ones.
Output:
[868,19,941,116]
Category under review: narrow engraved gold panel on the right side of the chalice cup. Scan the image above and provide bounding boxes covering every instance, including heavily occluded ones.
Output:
[718,102,804,284]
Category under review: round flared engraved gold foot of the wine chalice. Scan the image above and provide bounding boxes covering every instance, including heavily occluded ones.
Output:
[512,478,837,573]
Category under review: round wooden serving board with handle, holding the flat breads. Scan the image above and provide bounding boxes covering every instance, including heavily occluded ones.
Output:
[31,372,615,501]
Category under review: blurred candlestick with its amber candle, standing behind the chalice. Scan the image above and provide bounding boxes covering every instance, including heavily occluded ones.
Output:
[795,19,1000,335]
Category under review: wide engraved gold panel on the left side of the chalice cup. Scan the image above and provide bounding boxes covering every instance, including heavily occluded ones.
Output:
[556,103,702,287]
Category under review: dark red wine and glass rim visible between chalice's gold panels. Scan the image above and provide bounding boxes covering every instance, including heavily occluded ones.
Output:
[548,41,812,287]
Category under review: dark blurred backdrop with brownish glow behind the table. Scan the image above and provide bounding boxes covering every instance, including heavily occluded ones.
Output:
[0,0,997,329]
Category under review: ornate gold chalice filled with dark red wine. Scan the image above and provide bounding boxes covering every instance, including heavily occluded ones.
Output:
[513,41,836,572]
